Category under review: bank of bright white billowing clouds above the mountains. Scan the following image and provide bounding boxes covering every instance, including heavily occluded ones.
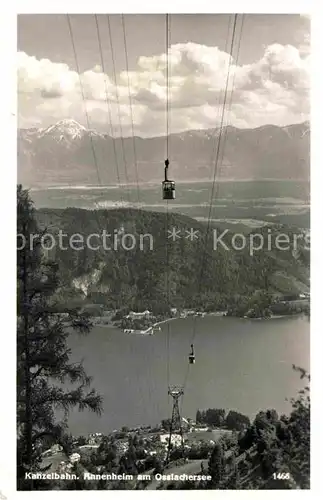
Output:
[18,34,310,137]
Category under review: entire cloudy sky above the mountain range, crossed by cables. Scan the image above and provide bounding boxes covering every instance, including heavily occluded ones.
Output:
[17,14,310,137]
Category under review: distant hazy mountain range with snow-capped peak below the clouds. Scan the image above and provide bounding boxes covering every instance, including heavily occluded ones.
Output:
[17,119,310,187]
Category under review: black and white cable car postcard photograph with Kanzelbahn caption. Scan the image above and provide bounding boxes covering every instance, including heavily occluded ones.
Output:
[6,3,319,492]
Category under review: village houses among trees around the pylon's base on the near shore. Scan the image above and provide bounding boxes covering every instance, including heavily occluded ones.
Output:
[42,417,232,482]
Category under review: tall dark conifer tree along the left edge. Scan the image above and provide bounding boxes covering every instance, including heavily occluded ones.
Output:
[17,186,102,489]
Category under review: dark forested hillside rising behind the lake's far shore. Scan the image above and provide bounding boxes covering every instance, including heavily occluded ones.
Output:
[37,208,309,310]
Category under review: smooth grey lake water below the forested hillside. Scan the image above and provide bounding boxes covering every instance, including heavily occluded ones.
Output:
[69,316,310,435]
